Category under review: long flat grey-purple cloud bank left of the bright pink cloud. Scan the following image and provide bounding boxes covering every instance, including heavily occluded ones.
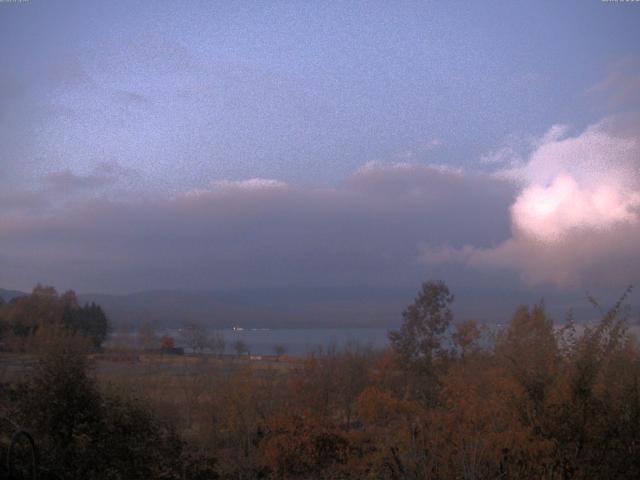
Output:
[0,164,514,291]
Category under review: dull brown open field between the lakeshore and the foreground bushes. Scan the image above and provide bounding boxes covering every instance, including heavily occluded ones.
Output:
[0,350,302,444]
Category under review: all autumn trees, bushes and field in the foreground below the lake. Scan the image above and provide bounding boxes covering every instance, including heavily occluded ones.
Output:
[0,282,640,479]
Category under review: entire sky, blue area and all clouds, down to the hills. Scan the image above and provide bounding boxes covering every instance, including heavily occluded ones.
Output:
[0,0,640,302]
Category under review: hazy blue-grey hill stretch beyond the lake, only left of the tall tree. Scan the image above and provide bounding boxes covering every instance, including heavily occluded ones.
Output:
[79,288,412,328]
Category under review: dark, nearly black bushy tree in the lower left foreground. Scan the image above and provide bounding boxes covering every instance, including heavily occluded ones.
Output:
[16,337,182,480]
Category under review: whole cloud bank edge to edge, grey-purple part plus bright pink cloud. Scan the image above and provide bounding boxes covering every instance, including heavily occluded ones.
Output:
[0,115,640,291]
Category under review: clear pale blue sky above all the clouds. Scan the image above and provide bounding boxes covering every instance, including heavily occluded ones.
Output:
[0,1,640,188]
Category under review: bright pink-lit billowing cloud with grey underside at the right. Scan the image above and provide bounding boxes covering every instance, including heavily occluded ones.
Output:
[423,116,640,287]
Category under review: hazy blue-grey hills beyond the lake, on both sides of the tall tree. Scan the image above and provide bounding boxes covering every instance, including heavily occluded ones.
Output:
[79,287,638,328]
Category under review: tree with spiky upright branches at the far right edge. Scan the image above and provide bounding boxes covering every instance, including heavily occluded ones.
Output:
[542,287,640,479]
